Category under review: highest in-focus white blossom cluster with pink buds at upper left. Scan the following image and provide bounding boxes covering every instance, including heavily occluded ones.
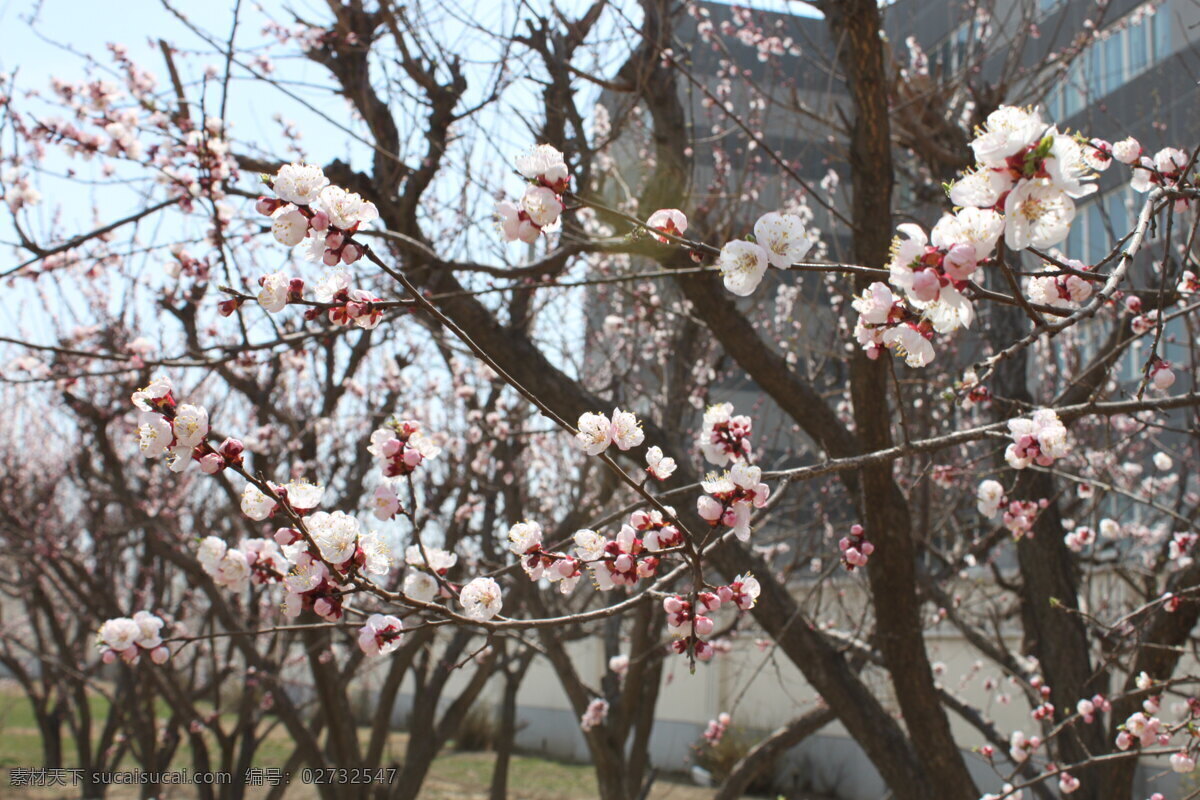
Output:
[254,164,379,266]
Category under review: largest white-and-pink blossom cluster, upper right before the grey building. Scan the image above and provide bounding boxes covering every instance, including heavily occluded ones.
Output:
[852,106,1161,367]
